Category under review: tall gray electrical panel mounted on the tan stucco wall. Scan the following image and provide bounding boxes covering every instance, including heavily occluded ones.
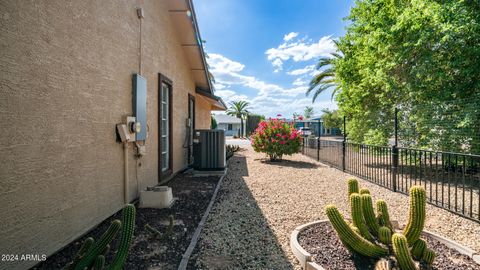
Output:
[133,74,147,141]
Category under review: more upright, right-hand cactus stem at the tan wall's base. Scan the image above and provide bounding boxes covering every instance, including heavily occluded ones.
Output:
[108,204,135,270]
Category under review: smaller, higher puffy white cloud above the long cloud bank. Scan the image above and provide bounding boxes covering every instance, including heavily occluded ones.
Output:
[265,36,336,70]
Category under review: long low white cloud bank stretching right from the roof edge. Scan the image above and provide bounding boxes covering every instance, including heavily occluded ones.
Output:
[207,51,336,117]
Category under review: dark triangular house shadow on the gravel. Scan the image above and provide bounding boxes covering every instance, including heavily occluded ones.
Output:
[187,154,292,270]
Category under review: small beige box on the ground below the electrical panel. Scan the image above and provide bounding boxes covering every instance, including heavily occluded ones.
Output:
[140,186,174,208]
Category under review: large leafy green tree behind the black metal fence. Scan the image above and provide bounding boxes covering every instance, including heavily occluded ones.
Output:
[330,0,480,152]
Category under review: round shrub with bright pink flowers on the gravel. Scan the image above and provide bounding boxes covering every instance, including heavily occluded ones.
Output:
[250,118,301,161]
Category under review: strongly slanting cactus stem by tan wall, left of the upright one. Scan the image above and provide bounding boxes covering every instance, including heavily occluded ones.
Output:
[75,219,122,270]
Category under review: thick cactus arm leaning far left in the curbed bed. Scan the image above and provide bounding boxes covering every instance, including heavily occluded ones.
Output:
[325,205,388,258]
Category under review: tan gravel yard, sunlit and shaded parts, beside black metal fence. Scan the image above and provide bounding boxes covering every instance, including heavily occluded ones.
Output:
[190,146,480,269]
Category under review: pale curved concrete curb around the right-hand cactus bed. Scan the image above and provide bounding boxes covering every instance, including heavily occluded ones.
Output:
[290,219,480,270]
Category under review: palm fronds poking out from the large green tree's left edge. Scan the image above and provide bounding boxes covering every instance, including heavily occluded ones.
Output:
[307,52,343,103]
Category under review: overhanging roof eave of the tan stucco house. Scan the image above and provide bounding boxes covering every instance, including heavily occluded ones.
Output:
[165,0,226,110]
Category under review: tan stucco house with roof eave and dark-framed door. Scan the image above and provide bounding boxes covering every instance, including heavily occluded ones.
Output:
[0,0,226,269]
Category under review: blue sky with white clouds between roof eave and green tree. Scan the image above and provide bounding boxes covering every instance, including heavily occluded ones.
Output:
[194,0,353,117]
